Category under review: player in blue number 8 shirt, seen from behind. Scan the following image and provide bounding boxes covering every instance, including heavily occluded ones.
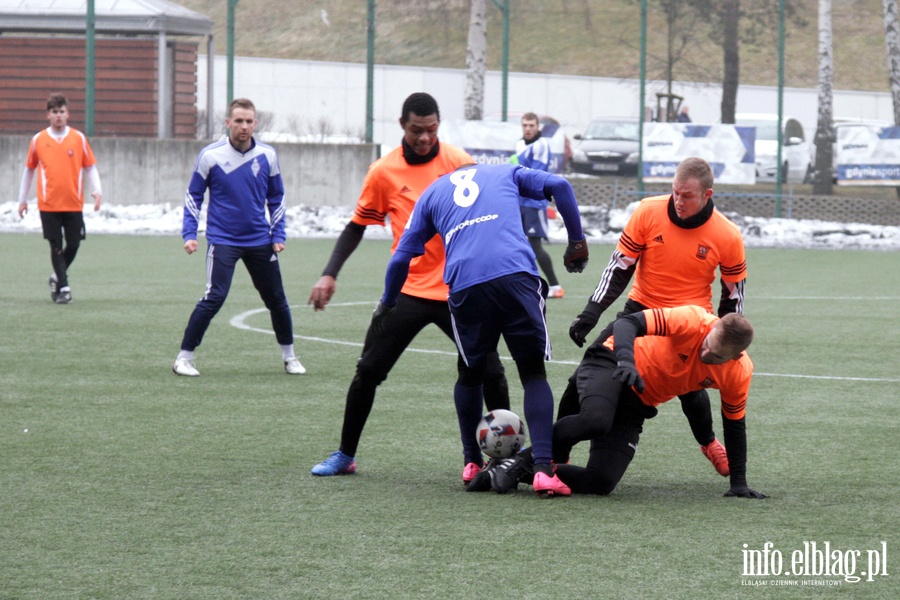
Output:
[371,165,588,496]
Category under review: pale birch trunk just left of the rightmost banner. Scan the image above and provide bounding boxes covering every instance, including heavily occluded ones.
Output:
[813,0,834,194]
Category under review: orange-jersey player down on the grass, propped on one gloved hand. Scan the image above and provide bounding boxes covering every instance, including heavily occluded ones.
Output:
[469,306,766,498]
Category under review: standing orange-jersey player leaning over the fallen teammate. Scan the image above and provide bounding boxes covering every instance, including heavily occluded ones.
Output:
[558,157,747,476]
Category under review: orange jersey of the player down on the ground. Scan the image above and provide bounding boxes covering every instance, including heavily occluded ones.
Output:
[604,306,753,420]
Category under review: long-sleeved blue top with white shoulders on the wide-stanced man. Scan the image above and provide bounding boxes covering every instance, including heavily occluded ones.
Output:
[181,137,285,247]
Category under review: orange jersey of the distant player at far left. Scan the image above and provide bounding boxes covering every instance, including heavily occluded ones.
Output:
[25,127,97,212]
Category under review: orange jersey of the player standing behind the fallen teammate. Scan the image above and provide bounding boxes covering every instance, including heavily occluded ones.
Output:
[616,195,747,312]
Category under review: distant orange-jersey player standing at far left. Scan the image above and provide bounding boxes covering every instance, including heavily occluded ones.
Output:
[19,94,102,304]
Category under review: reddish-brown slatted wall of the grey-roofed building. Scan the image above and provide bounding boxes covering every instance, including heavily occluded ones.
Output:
[0,36,197,139]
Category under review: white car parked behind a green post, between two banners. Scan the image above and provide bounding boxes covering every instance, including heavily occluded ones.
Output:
[734,113,810,183]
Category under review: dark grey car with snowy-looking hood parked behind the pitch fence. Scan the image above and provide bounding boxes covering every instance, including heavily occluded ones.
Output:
[572,117,640,177]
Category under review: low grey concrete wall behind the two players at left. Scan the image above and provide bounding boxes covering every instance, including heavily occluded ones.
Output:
[0,136,377,209]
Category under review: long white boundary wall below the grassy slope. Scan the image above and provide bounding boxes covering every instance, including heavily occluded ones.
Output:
[197,55,893,147]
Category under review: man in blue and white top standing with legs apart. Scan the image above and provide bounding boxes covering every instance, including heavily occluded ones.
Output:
[172,98,306,377]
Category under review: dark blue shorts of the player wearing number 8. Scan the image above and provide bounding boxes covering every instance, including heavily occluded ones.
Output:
[449,273,551,367]
